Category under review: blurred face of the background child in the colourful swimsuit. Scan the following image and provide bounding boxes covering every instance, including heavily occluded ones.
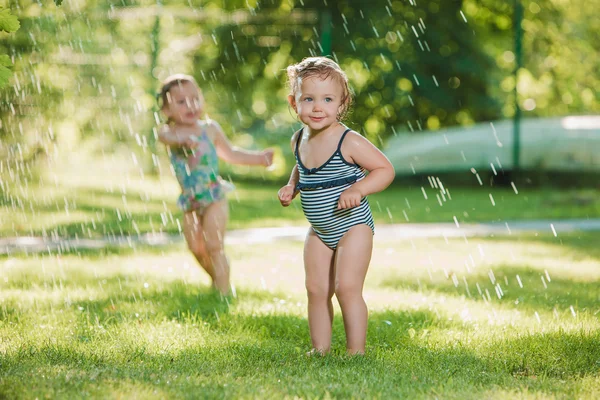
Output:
[163,82,204,125]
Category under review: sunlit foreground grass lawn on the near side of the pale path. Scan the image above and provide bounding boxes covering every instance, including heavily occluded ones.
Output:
[0,233,600,399]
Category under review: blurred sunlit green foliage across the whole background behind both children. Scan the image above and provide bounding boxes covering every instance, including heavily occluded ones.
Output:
[0,0,600,173]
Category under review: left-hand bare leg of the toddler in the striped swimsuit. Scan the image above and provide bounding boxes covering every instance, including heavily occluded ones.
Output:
[304,229,335,353]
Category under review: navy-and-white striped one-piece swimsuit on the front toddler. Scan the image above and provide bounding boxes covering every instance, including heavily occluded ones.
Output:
[294,129,375,250]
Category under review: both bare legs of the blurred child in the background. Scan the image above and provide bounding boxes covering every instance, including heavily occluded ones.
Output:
[183,200,230,293]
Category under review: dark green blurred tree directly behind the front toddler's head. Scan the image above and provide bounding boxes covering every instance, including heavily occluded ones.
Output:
[214,0,502,144]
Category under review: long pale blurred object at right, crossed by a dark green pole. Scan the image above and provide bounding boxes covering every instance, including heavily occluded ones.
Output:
[384,116,600,175]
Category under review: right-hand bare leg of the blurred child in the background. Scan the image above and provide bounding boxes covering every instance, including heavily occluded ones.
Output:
[202,199,231,294]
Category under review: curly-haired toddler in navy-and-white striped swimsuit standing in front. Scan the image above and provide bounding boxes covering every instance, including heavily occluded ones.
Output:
[278,57,394,354]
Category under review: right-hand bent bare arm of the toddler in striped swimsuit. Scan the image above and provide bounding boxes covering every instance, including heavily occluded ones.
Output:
[339,132,396,208]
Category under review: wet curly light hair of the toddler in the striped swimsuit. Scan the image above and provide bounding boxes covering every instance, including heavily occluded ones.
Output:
[287,57,352,121]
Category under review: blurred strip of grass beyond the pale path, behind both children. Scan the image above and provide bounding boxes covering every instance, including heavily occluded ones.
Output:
[0,155,600,237]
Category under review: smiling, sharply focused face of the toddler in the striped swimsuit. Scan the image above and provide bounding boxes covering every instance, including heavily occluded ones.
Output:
[289,76,344,131]
